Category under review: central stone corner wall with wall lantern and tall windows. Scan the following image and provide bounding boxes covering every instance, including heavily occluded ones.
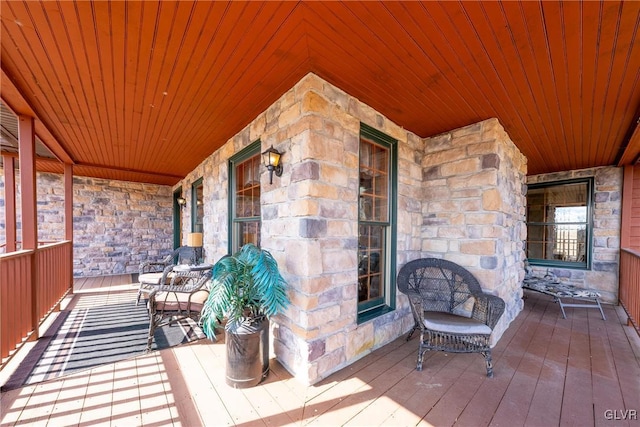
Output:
[179,74,422,383]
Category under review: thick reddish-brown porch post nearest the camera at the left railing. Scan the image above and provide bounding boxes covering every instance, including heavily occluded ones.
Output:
[18,115,40,340]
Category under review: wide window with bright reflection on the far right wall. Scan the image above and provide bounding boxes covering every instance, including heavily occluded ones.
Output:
[527,178,593,269]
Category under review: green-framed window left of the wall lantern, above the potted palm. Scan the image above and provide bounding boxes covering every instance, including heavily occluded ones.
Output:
[228,140,262,253]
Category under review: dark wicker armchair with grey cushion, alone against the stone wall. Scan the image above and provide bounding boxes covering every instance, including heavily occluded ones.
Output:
[398,258,505,378]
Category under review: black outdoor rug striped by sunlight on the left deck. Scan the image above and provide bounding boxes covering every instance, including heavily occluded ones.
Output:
[2,297,205,390]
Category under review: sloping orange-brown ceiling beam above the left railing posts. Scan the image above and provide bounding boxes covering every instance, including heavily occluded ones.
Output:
[0,69,75,164]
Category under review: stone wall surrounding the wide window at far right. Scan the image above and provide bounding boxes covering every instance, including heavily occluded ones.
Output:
[527,167,623,304]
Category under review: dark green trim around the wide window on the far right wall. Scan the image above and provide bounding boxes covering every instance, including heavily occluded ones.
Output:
[526,176,595,270]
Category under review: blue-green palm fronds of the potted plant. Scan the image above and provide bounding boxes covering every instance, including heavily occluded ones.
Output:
[201,244,289,339]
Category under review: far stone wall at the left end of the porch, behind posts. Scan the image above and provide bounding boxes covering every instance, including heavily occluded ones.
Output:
[0,169,173,277]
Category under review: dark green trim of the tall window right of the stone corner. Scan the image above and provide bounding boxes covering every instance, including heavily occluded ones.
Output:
[356,123,398,324]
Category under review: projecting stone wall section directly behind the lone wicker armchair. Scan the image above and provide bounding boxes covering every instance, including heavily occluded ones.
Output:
[422,119,527,343]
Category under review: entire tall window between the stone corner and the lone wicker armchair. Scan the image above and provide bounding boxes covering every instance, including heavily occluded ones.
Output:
[357,124,398,323]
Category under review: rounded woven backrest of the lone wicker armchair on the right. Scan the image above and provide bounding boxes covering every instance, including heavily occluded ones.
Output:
[397,258,482,313]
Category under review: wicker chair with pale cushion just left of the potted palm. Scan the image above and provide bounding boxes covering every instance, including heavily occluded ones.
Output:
[147,269,211,351]
